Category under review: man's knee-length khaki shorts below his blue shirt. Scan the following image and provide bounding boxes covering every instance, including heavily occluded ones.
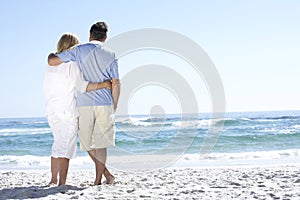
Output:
[78,106,116,151]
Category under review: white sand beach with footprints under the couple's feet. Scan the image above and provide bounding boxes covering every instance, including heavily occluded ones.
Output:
[0,166,300,200]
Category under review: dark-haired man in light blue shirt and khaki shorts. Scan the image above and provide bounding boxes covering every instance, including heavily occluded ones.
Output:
[48,22,120,185]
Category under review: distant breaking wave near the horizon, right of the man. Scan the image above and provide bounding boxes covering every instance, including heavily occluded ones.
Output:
[117,117,300,136]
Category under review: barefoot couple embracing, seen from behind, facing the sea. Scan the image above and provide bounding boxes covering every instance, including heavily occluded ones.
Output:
[44,22,120,185]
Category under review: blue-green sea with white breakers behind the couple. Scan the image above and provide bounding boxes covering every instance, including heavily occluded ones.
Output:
[0,111,300,170]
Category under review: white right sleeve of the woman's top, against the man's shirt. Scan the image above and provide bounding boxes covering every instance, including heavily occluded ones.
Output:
[70,62,89,93]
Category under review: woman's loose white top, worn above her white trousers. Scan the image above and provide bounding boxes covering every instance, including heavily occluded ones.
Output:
[44,62,89,118]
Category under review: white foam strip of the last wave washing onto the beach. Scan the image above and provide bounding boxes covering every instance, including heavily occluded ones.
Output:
[0,149,300,170]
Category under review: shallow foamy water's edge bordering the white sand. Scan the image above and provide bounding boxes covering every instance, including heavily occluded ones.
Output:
[0,149,300,172]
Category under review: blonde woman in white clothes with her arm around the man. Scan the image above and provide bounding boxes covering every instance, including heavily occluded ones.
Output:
[44,33,114,185]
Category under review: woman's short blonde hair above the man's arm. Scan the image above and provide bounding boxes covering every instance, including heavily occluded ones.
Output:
[56,33,79,53]
